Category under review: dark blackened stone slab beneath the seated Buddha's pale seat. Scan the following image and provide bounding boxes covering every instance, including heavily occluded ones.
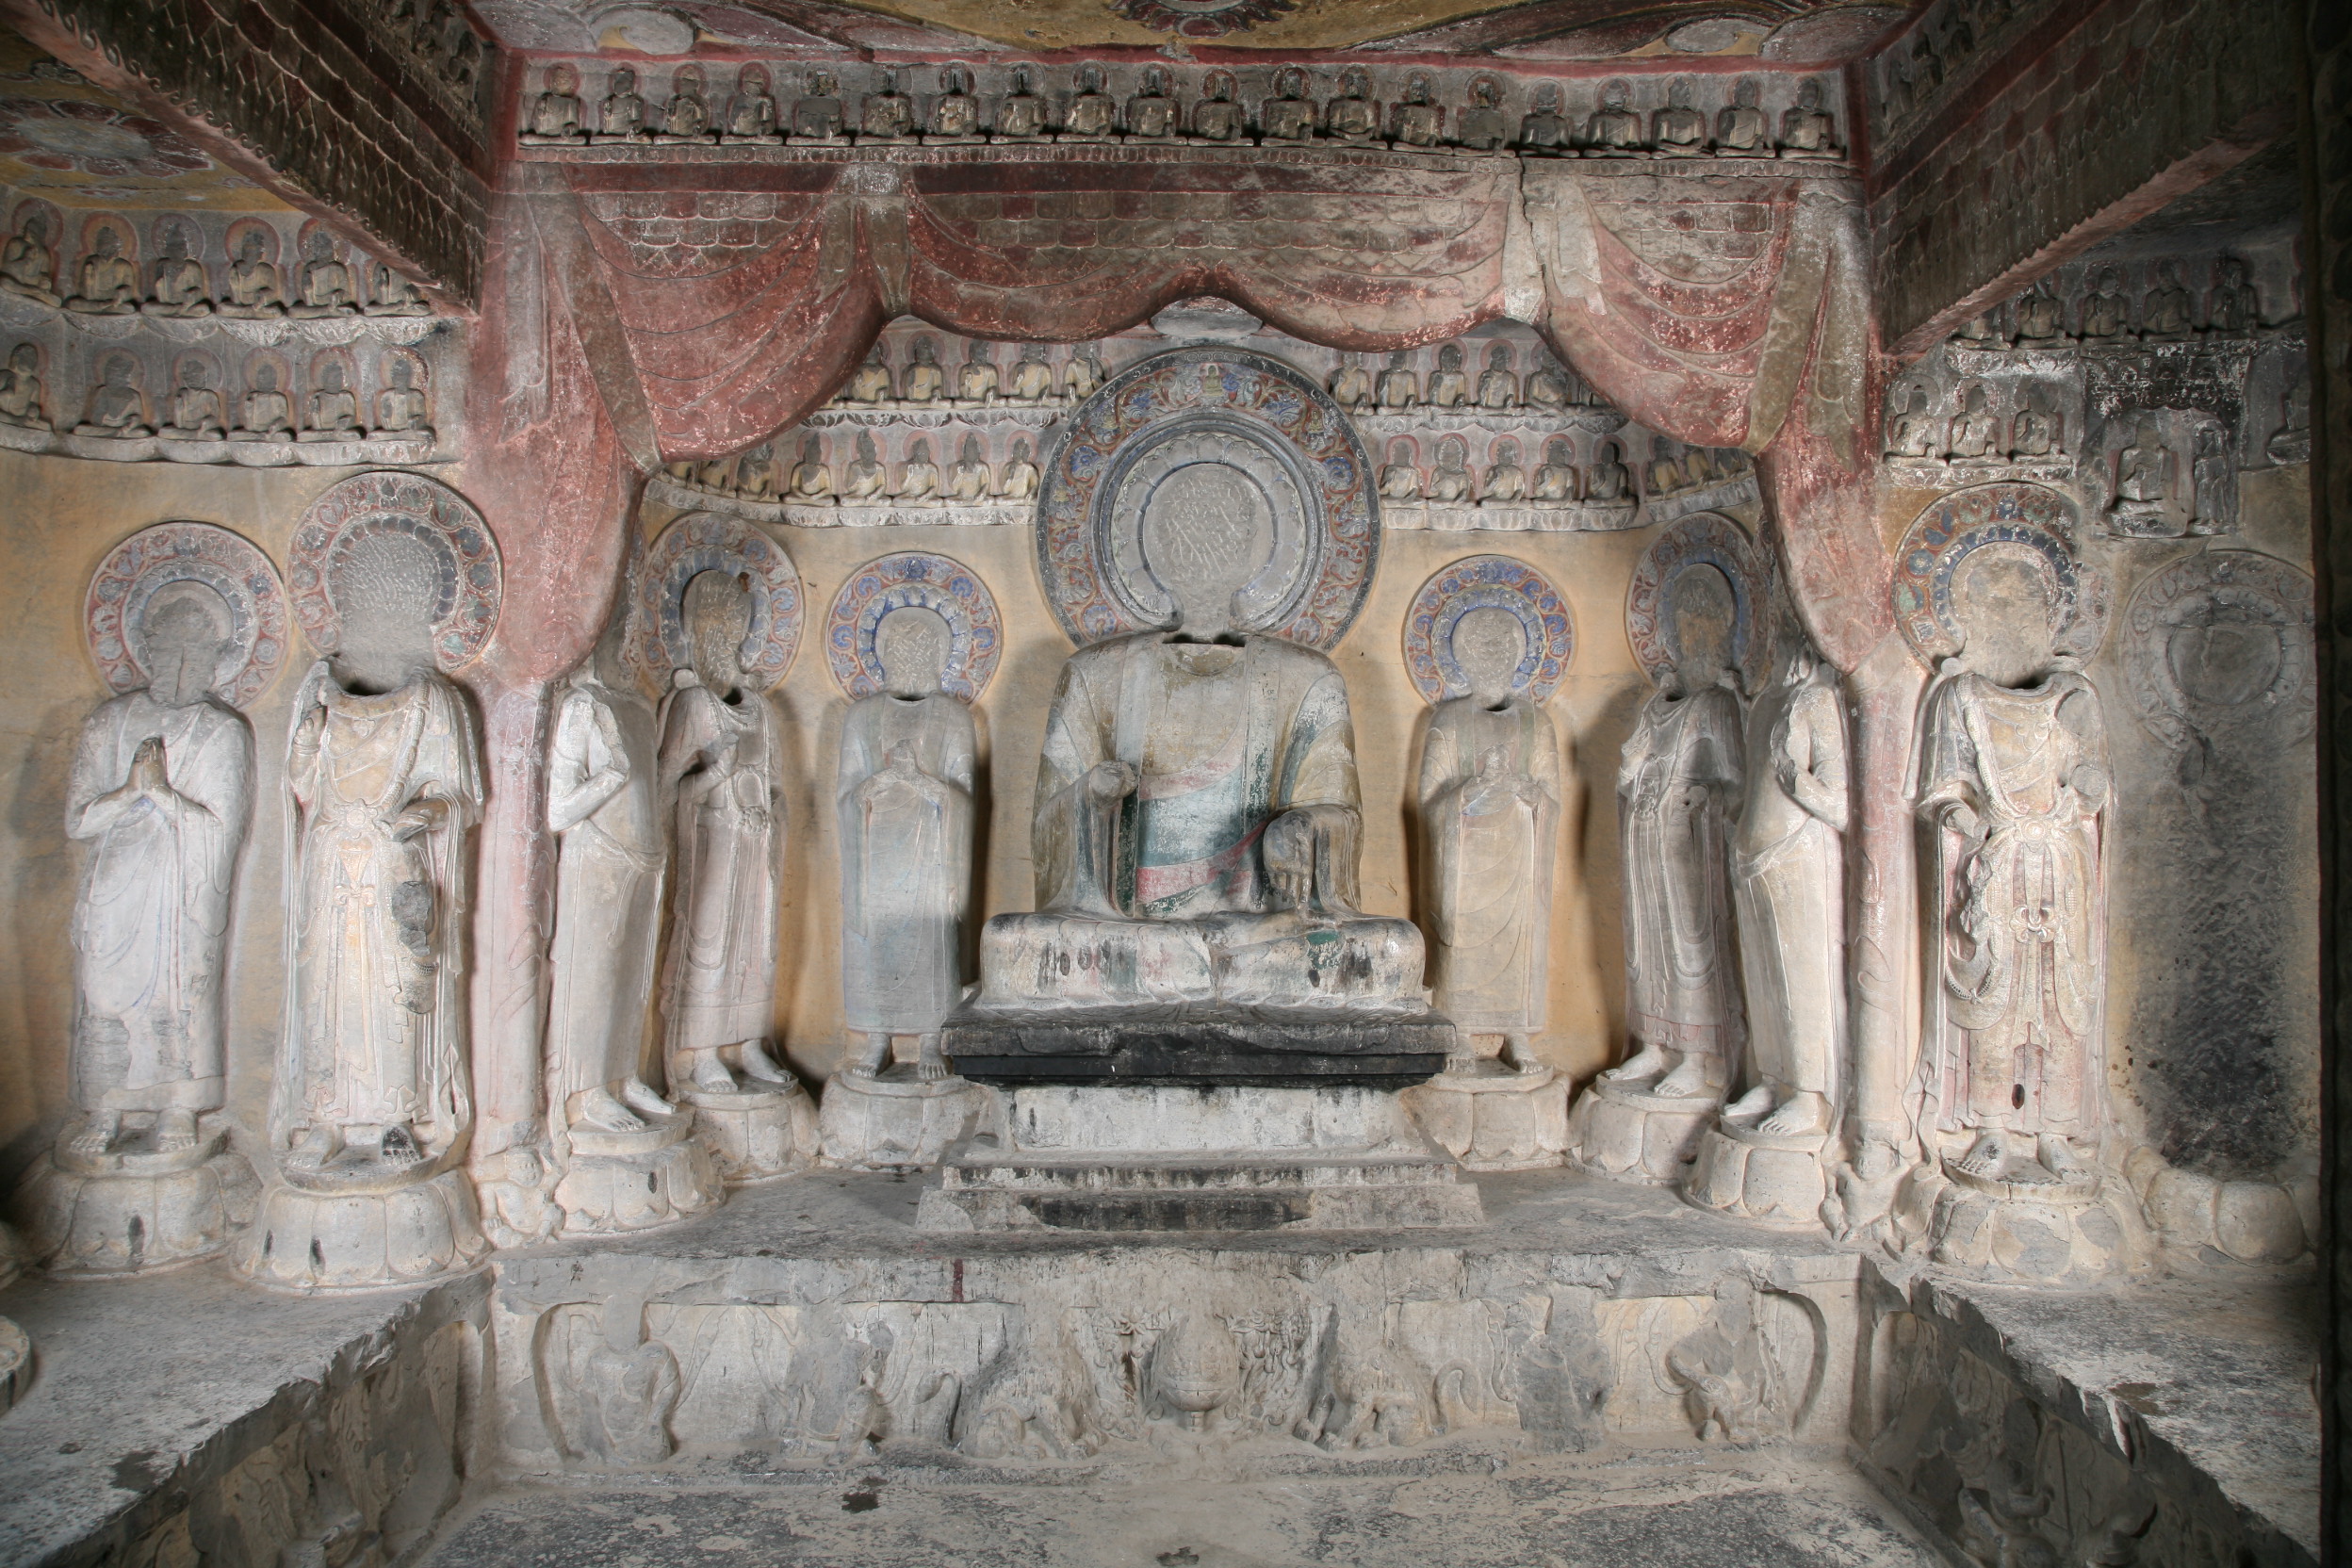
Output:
[940,1004,1454,1088]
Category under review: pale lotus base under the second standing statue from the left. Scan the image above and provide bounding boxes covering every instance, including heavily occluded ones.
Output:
[231,1166,489,1293]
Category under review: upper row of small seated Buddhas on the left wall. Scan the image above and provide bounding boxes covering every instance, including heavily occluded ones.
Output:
[0,203,433,318]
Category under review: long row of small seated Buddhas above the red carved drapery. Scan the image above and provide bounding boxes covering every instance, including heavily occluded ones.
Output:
[522,63,1844,160]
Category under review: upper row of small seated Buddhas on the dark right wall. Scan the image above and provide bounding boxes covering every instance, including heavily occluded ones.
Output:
[1952,256,2291,348]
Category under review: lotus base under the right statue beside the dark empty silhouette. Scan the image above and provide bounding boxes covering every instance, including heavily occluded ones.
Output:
[1929,1159,2152,1286]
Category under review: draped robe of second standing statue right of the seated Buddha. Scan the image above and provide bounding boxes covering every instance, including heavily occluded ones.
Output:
[1618,686,1743,1065]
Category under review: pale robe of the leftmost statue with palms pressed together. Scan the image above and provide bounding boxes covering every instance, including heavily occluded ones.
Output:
[66,691,254,1112]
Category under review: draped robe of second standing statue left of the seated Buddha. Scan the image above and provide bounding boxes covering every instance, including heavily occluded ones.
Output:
[661,686,783,1077]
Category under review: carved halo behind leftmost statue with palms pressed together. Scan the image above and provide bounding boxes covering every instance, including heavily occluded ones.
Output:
[82,522,287,708]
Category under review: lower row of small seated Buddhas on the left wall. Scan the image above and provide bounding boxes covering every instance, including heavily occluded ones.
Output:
[0,343,433,442]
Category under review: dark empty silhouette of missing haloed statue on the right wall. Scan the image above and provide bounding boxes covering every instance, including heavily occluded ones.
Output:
[2115,550,2319,1269]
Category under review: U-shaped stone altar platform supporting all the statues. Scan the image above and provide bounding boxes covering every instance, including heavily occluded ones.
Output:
[0,1170,2319,1568]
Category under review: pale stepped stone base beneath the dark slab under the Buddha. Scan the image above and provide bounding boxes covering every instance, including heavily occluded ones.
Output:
[917,1084,1484,1232]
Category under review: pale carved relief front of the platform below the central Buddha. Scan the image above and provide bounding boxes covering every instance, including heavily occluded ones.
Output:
[498,1253,1851,1469]
